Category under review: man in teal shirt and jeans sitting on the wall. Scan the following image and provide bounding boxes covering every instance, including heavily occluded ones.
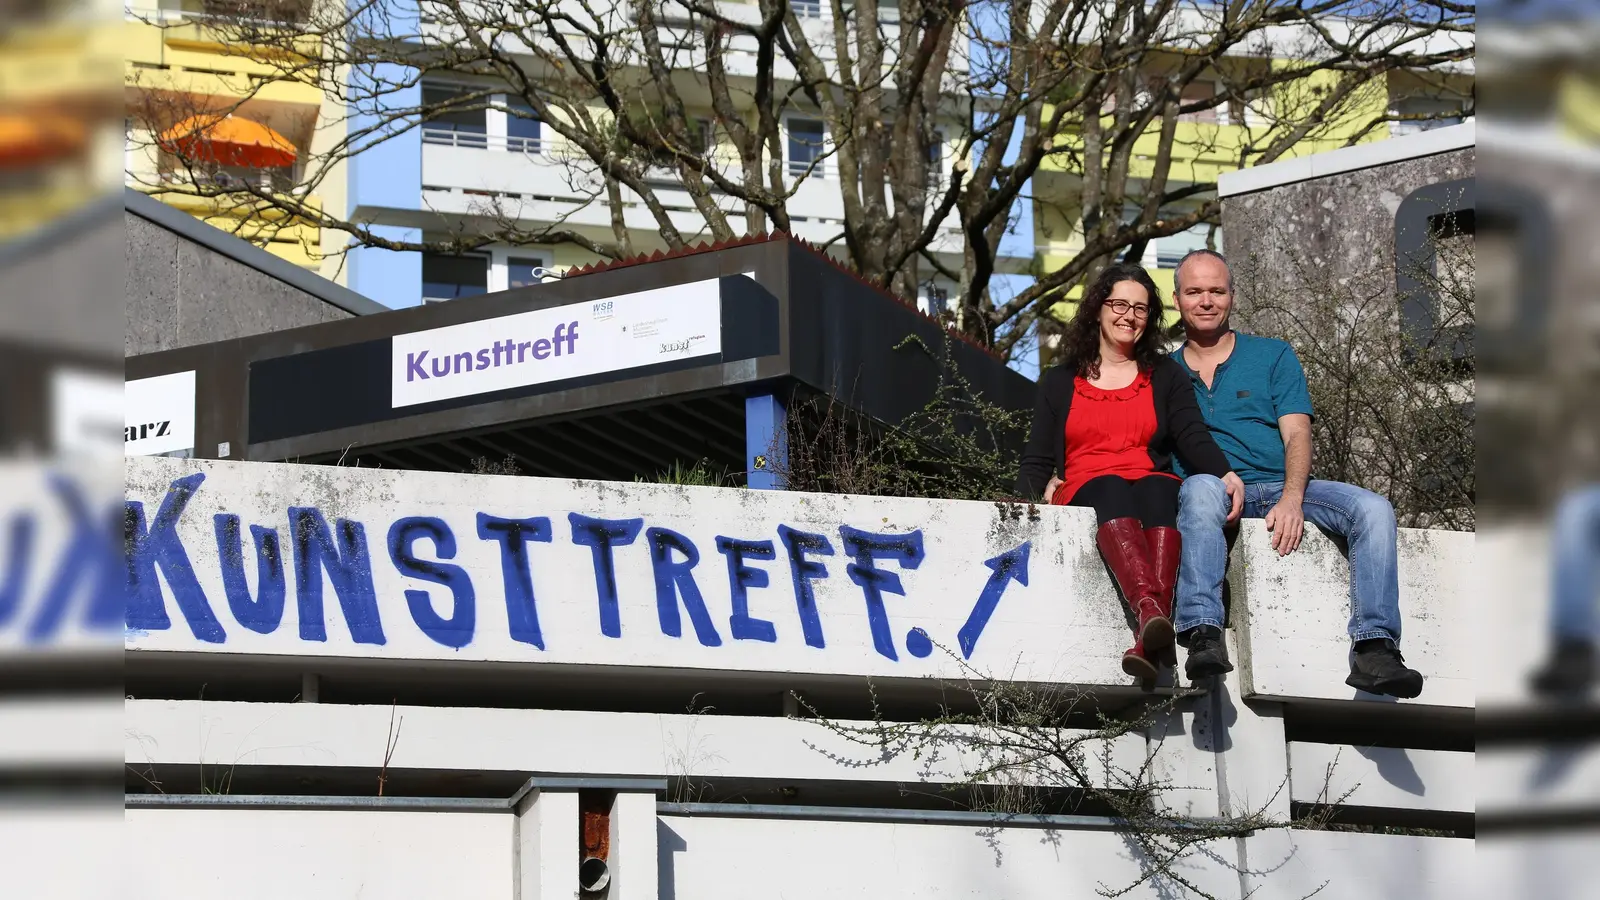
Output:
[1173,250,1422,697]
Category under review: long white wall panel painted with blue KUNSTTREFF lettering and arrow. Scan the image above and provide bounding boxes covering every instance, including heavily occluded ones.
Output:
[125,460,1131,684]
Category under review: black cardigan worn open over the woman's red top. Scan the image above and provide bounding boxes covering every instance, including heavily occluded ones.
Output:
[1016,357,1232,500]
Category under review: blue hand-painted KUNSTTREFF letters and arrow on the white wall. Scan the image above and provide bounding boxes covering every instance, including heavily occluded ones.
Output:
[118,472,1030,661]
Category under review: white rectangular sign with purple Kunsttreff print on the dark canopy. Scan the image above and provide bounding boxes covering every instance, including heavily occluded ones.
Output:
[390,279,722,408]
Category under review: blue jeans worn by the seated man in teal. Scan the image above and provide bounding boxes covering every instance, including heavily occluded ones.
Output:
[1173,476,1400,644]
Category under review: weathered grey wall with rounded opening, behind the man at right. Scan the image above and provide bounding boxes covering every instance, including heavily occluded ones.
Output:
[1222,139,1477,528]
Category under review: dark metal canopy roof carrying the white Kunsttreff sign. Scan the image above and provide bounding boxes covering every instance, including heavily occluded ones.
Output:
[126,235,1034,484]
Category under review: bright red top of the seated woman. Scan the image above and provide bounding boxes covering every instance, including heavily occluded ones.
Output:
[1051,372,1178,504]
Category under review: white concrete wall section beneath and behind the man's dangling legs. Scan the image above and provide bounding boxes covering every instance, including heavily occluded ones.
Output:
[1229,519,1475,708]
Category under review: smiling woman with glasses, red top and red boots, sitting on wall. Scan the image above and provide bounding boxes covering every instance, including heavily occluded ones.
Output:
[1018,264,1229,687]
